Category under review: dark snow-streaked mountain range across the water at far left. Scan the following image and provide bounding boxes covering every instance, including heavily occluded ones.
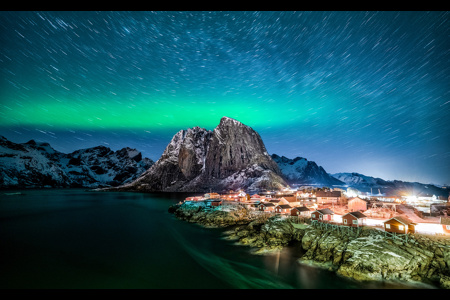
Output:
[0,136,153,188]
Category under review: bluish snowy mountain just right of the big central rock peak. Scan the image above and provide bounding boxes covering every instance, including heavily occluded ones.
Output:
[272,154,344,186]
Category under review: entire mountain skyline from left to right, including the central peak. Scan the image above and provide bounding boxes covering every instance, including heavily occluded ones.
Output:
[0,117,448,197]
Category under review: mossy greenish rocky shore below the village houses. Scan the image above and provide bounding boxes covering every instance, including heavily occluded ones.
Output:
[169,204,450,289]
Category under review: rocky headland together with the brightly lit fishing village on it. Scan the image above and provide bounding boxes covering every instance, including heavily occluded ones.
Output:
[169,187,450,289]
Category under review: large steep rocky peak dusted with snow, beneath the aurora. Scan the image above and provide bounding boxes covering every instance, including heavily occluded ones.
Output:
[119,117,287,192]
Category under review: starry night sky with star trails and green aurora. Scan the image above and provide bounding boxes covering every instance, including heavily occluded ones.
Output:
[0,11,450,184]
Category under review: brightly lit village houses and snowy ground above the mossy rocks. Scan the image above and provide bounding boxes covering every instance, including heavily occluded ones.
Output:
[179,187,450,238]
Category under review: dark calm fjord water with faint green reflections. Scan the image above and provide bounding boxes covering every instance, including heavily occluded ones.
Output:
[0,189,430,289]
